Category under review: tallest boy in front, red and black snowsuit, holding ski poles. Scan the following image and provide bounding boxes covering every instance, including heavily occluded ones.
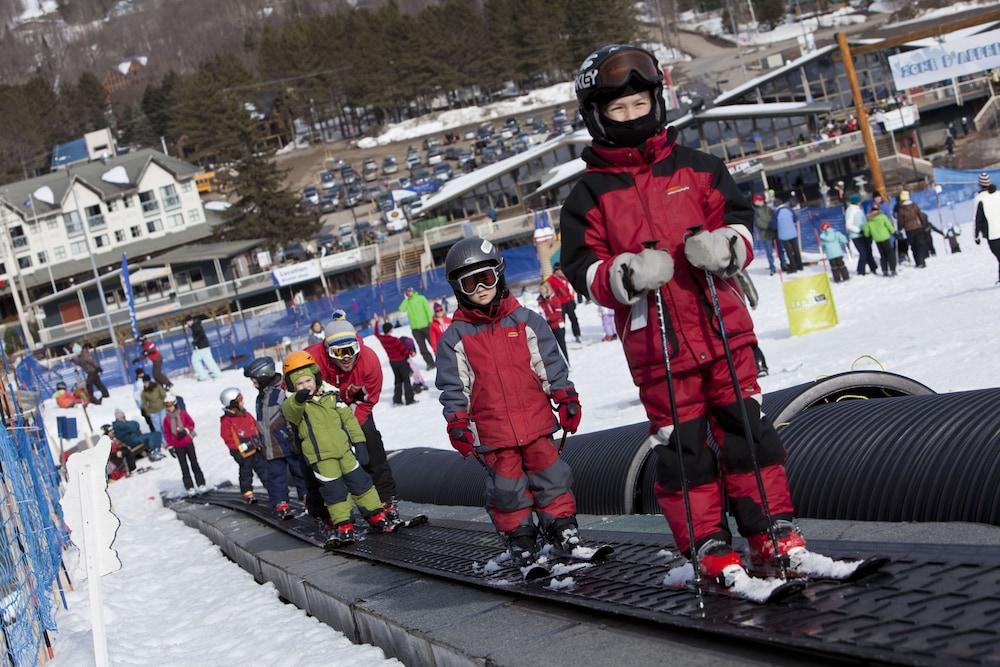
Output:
[561,45,808,586]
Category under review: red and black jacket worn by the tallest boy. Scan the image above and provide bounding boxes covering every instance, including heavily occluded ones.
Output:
[560,128,756,385]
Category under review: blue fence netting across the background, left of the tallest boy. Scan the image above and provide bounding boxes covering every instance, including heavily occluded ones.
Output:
[17,246,541,399]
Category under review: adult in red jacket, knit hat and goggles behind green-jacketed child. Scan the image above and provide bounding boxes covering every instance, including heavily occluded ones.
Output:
[306,318,400,523]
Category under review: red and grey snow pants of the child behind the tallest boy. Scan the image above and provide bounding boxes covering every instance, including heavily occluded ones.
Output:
[482,436,576,533]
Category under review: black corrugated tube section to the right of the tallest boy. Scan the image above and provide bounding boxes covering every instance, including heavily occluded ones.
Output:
[781,389,1000,525]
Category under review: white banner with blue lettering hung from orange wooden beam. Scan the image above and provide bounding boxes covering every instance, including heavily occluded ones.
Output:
[889,30,1000,90]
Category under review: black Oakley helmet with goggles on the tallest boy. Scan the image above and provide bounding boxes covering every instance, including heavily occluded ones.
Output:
[576,44,667,144]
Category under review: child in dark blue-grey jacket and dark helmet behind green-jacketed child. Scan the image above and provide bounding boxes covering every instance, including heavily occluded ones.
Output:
[243,357,306,519]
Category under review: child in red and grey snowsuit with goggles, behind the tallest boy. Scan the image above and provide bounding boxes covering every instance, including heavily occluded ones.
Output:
[437,238,581,567]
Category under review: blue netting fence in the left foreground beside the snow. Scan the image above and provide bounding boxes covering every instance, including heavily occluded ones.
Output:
[0,344,67,667]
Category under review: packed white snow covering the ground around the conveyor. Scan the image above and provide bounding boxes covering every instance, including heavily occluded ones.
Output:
[44,218,1000,666]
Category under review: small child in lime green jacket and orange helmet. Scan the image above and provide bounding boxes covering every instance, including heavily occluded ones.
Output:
[281,351,394,549]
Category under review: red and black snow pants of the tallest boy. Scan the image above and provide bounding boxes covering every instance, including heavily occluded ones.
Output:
[639,346,793,553]
